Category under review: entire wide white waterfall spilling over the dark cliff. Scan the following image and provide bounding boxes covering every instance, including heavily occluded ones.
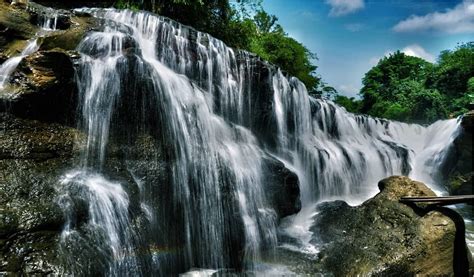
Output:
[56,9,466,276]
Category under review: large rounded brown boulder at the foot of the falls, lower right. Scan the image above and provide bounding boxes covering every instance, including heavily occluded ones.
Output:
[274,176,470,276]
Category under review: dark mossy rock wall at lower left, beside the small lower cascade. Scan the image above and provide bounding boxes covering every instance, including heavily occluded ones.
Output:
[0,114,80,275]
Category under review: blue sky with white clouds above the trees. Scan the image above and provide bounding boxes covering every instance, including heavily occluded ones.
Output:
[263,0,474,96]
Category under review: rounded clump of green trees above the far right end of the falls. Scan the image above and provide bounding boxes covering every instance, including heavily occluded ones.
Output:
[335,42,474,123]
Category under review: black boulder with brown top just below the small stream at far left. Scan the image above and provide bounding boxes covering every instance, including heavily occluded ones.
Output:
[0,49,79,124]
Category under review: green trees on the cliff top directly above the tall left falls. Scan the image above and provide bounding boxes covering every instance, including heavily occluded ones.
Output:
[115,0,321,92]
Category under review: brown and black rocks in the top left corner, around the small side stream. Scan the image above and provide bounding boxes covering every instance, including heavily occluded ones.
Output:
[0,1,96,126]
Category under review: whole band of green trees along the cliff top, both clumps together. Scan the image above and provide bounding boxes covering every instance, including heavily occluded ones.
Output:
[115,0,474,123]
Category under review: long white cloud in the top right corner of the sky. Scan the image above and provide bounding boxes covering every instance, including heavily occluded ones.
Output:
[393,0,474,34]
